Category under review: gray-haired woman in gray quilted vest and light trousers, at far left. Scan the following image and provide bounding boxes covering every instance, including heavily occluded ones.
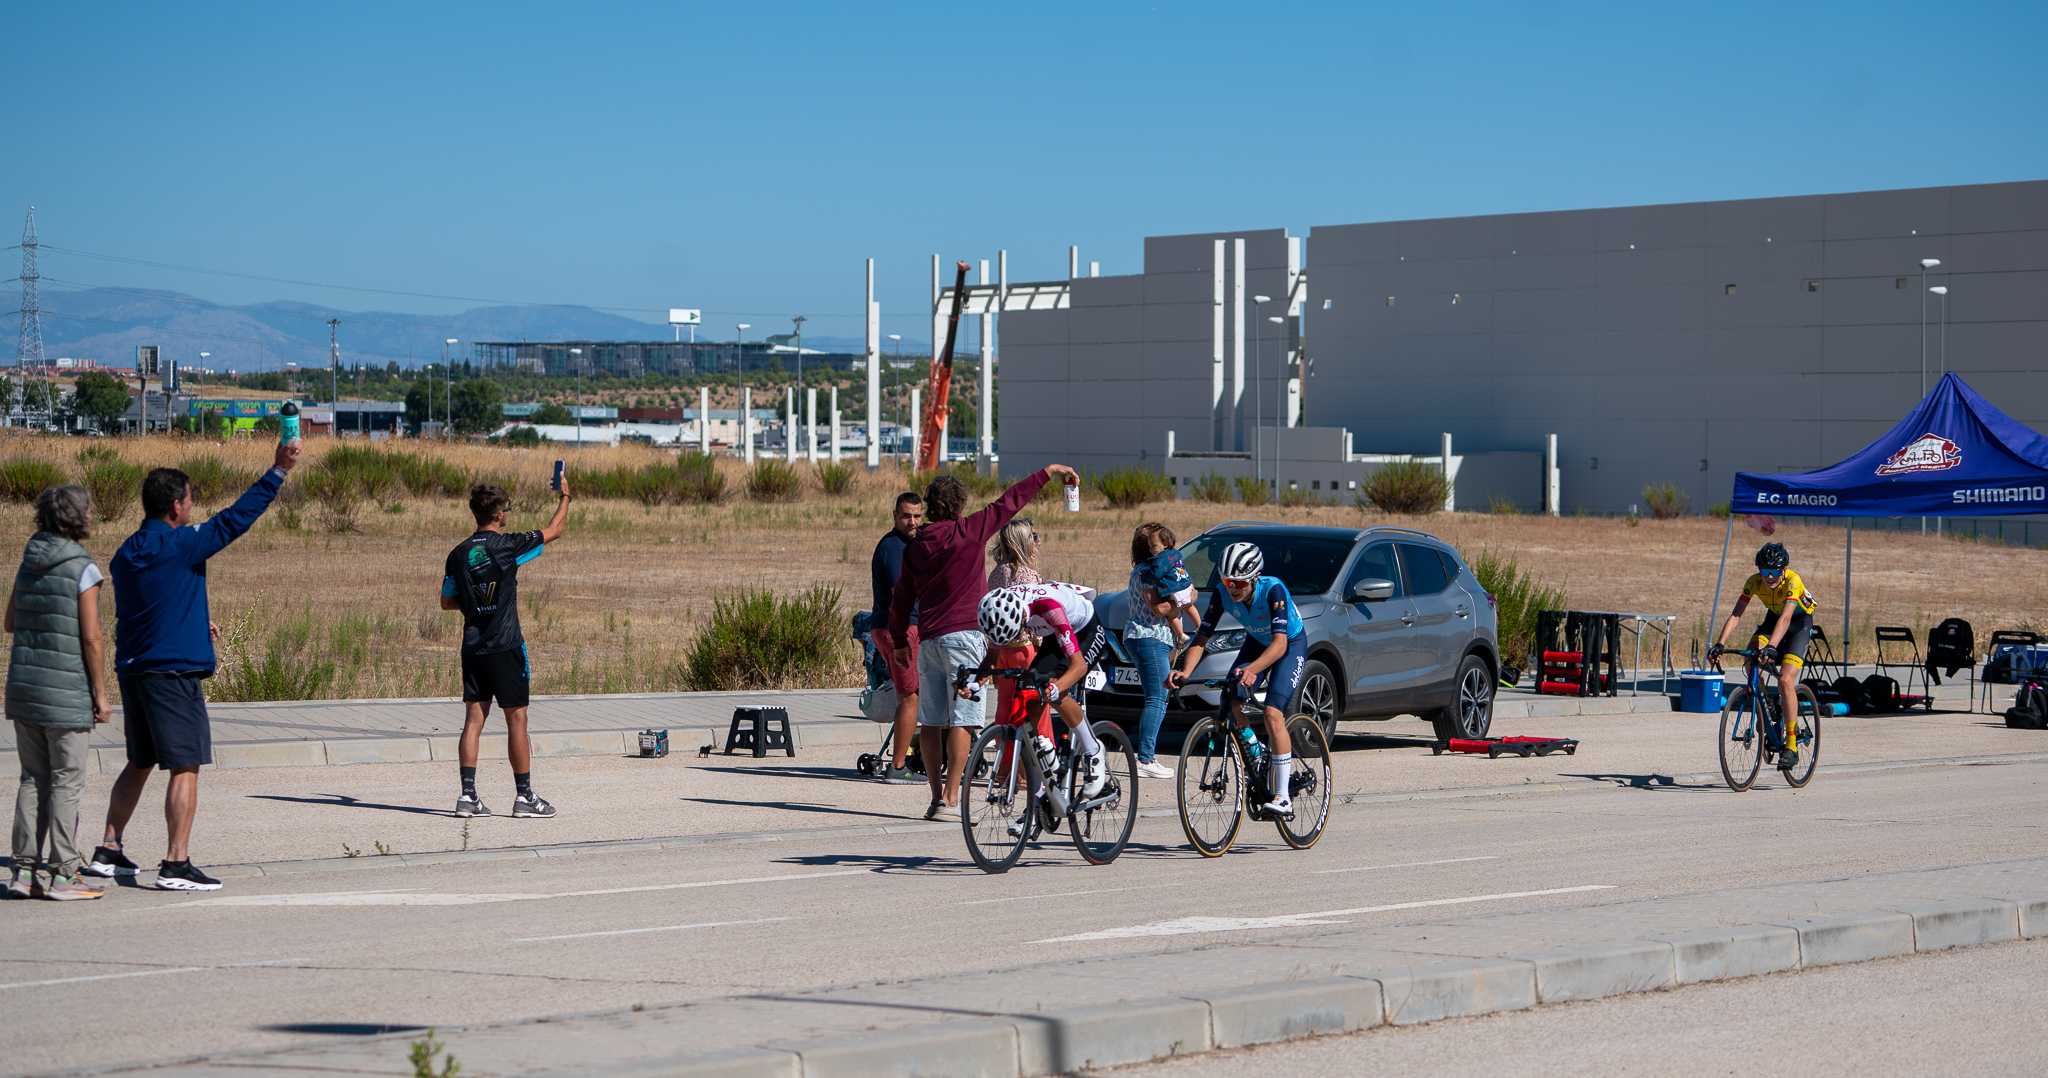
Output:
[6,486,111,902]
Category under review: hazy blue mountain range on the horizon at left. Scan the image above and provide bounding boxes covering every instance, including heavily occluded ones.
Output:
[0,289,905,371]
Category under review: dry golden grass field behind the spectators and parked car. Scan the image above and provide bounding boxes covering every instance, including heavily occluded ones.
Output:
[0,437,2048,699]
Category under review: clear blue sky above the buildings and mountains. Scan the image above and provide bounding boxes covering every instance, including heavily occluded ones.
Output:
[0,2,2048,336]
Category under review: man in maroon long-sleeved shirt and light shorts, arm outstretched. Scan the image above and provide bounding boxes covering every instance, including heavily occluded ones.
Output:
[889,463,1081,820]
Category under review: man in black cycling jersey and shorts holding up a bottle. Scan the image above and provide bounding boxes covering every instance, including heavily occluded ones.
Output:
[440,475,569,820]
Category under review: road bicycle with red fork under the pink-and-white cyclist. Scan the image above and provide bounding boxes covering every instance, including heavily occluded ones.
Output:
[952,666,1139,873]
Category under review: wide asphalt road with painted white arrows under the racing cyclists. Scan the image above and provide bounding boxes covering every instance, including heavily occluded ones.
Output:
[0,715,2048,1072]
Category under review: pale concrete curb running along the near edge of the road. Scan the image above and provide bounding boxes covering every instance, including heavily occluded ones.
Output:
[629,896,2048,1078]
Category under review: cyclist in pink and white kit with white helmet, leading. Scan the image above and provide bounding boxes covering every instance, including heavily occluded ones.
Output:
[963,582,1110,797]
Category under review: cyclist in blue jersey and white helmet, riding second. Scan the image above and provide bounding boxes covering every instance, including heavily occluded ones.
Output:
[1167,543,1309,820]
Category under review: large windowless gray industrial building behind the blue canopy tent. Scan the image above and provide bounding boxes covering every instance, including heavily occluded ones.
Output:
[997,180,2048,512]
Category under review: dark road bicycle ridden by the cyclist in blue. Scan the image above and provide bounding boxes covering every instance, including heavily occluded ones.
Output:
[1174,678,1335,857]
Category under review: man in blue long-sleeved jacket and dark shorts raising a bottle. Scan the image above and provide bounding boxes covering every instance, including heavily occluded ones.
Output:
[86,441,299,892]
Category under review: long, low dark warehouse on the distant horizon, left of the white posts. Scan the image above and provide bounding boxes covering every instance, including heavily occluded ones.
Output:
[475,346,866,385]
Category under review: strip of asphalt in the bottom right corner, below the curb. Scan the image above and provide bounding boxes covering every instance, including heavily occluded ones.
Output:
[1100,941,2048,1078]
